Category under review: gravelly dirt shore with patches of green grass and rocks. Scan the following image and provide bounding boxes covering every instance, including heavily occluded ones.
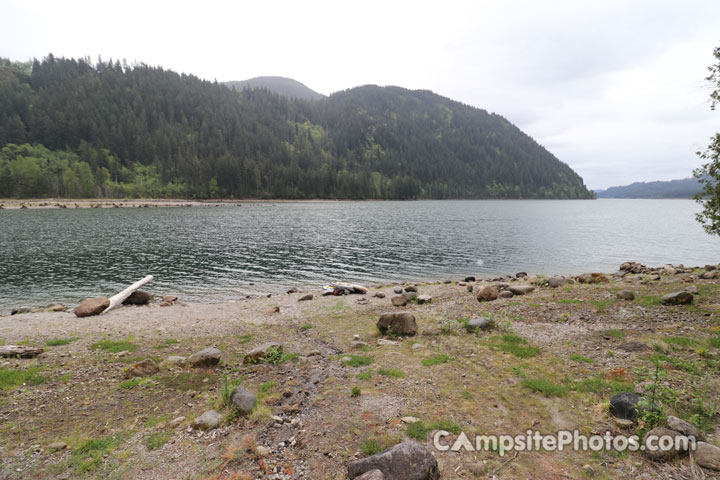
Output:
[0,270,720,480]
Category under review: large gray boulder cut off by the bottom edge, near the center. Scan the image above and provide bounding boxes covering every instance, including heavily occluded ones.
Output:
[347,441,440,480]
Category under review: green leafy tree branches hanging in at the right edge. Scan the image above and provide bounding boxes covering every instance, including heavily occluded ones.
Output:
[693,47,720,235]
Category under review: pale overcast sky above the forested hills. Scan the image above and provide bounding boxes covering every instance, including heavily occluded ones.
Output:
[0,0,720,188]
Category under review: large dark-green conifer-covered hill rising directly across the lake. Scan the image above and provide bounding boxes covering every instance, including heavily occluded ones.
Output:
[0,55,592,199]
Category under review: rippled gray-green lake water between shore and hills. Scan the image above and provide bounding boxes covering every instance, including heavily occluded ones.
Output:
[0,200,720,311]
